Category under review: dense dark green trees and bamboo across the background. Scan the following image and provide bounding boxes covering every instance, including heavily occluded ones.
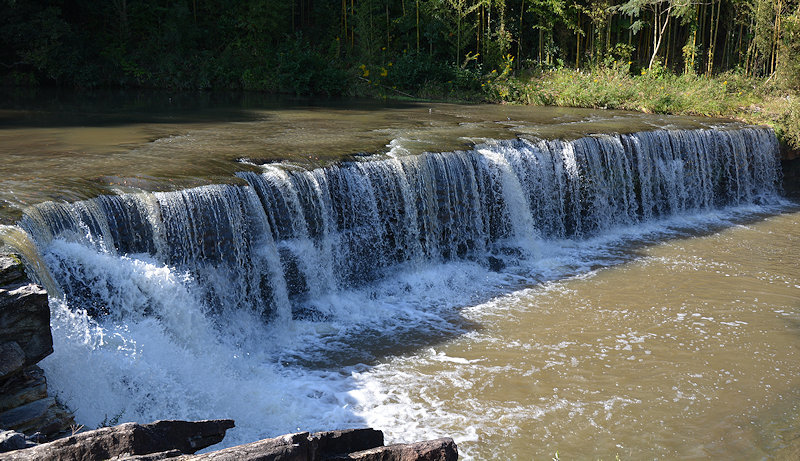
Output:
[0,0,800,93]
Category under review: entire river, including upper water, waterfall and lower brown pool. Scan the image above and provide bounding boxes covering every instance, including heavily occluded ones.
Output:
[0,94,800,460]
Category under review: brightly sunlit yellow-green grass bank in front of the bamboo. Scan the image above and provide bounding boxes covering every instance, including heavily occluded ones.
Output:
[485,63,800,150]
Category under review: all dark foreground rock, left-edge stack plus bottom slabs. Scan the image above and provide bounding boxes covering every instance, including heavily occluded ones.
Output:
[0,253,458,461]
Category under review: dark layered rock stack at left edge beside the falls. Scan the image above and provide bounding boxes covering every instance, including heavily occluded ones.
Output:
[0,254,75,440]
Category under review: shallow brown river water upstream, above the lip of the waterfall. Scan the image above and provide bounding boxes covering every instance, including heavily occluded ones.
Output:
[0,92,724,224]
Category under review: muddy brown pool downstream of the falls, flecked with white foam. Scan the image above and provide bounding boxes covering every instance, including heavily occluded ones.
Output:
[354,211,800,460]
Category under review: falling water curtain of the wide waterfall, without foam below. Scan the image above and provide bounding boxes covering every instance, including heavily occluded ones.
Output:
[20,127,779,320]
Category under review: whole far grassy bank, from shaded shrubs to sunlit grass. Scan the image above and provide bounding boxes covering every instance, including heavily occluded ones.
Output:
[350,62,800,151]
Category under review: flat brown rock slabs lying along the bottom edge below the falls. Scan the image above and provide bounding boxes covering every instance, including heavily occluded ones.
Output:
[0,419,458,461]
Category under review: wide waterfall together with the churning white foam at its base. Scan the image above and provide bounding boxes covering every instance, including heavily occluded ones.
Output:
[14,127,781,452]
